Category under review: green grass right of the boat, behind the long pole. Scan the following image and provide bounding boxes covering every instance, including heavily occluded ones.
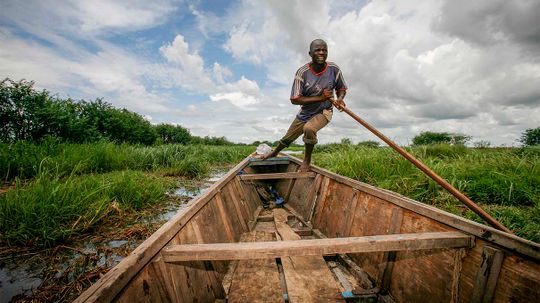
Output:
[314,145,540,242]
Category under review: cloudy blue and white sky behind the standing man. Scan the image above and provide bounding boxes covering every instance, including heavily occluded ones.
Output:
[0,0,540,146]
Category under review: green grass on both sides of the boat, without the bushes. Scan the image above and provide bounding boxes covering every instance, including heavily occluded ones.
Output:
[0,142,540,246]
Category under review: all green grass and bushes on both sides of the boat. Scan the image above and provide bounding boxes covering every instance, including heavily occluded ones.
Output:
[0,79,540,247]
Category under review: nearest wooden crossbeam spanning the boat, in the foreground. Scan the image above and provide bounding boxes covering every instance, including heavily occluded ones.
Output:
[162,232,474,262]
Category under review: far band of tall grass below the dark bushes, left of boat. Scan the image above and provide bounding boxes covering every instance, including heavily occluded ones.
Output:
[0,141,254,181]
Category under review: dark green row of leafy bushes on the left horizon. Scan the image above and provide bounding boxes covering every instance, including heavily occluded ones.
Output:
[0,78,233,145]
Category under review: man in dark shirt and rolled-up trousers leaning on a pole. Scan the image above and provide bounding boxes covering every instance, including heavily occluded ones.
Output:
[262,39,347,171]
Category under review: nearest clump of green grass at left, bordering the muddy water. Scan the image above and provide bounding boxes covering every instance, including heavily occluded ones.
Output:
[0,170,172,247]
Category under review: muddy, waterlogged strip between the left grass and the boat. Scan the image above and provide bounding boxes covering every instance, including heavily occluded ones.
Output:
[0,168,227,303]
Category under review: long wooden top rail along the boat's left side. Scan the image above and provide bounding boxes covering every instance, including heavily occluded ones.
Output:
[74,158,254,302]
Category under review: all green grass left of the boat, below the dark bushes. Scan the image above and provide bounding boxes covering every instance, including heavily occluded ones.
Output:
[0,142,253,247]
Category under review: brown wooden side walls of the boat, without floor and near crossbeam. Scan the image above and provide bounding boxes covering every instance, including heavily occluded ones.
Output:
[76,156,540,302]
